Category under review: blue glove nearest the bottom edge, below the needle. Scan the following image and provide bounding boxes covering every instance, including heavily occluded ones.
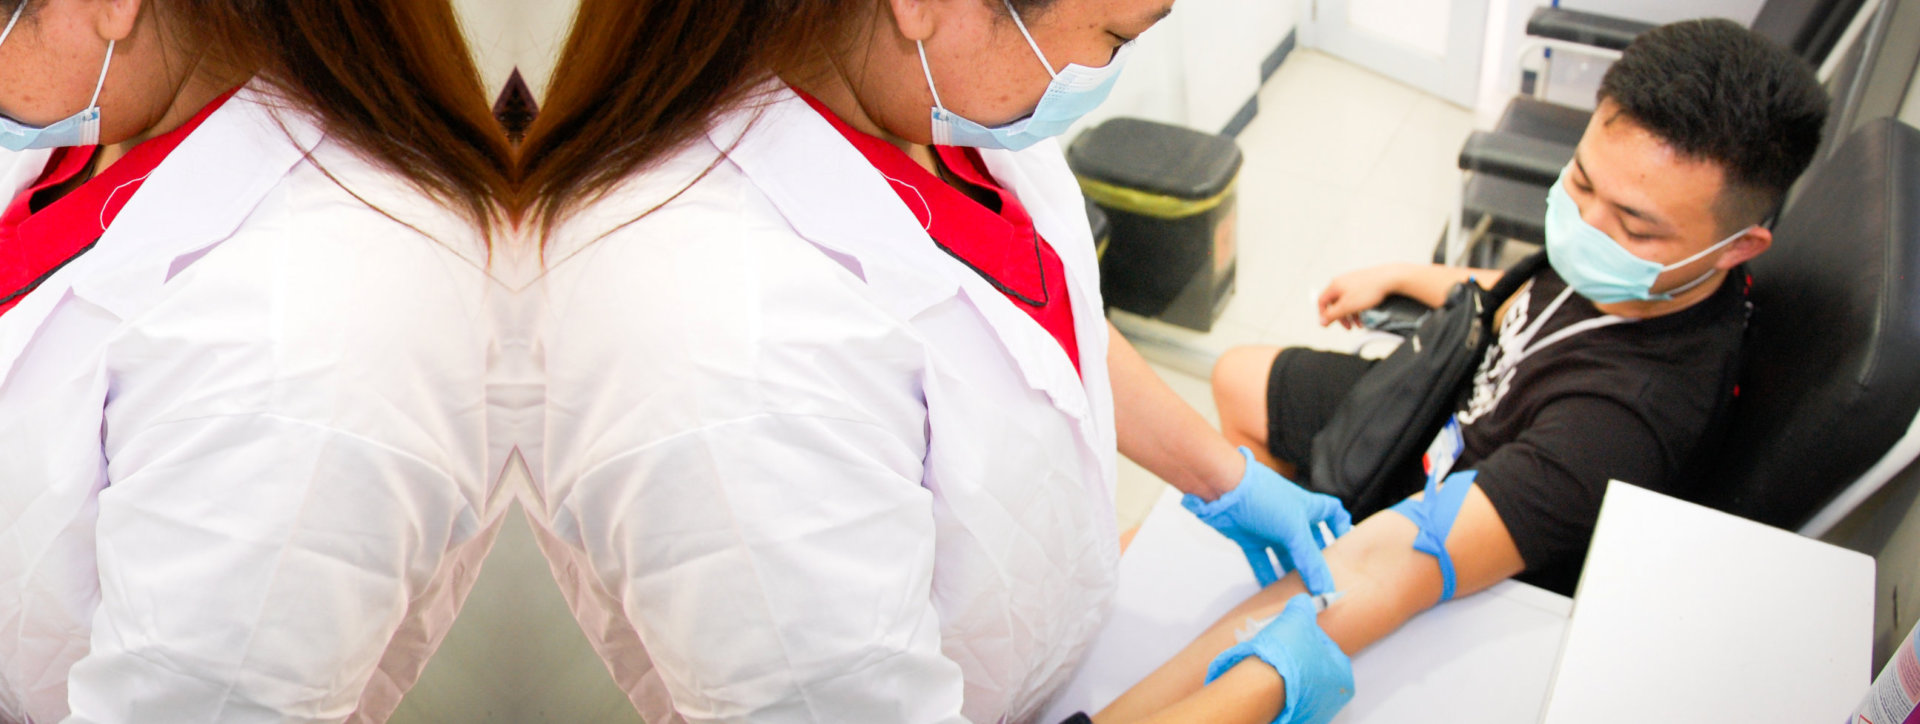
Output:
[1206,593,1354,724]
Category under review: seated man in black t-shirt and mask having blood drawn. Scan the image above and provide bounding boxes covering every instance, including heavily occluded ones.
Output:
[1094,21,1826,724]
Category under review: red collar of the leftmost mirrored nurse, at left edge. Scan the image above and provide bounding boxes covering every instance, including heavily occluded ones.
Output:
[0,88,238,313]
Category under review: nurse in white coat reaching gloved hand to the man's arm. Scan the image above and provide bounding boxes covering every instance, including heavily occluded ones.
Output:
[522,0,1346,722]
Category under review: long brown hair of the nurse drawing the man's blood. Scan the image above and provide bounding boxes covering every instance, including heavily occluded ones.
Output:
[520,0,1052,240]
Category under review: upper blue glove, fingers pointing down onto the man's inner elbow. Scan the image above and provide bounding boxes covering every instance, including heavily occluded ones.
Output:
[1181,447,1354,595]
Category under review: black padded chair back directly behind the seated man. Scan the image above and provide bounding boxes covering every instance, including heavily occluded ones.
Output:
[1692,119,1920,536]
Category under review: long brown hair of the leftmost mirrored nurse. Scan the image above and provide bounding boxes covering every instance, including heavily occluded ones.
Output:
[0,0,513,229]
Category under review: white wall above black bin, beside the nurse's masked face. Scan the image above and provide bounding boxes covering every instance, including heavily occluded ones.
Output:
[1068,0,1296,138]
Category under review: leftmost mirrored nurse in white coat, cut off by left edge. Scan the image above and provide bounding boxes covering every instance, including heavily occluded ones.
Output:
[0,0,505,724]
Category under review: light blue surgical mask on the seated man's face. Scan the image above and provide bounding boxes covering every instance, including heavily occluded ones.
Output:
[1548,171,1753,303]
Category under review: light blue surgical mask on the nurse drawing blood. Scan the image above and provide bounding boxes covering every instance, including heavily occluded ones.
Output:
[916,2,1133,152]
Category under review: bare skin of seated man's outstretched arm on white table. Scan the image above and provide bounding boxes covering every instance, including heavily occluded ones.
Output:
[1094,488,1524,724]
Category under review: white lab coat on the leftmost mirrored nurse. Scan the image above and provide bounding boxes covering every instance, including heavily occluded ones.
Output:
[0,86,503,724]
